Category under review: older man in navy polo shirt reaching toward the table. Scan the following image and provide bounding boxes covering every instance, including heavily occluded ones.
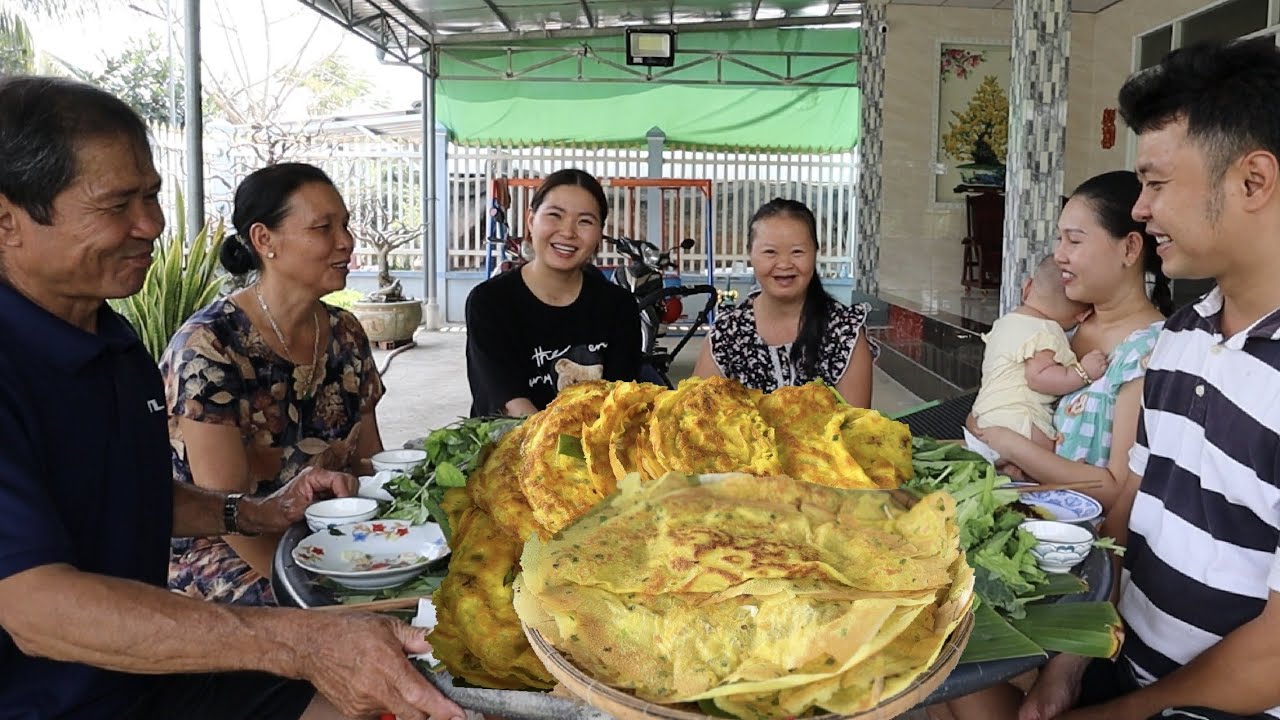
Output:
[0,77,462,720]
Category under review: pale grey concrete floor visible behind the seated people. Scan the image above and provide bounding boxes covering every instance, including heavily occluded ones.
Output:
[374,328,920,447]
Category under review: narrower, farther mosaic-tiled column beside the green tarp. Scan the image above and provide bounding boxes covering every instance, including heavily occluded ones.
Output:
[854,0,886,297]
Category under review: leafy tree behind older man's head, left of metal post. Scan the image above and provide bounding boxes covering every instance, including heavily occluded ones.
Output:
[70,32,186,127]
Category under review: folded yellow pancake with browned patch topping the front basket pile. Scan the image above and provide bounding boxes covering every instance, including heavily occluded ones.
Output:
[524,474,959,594]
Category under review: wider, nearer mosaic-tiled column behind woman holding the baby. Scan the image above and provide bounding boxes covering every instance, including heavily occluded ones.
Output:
[1000,0,1071,313]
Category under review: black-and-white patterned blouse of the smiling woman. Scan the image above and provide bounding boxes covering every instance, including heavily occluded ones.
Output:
[710,291,879,392]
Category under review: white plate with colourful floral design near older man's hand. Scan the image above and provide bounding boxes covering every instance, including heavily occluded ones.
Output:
[293,520,449,589]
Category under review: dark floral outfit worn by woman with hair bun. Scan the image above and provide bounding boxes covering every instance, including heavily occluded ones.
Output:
[160,299,384,605]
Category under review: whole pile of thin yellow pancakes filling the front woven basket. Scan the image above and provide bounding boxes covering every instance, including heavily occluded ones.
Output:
[516,475,972,717]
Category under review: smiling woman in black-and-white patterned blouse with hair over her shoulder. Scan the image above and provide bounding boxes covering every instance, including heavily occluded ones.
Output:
[694,197,879,407]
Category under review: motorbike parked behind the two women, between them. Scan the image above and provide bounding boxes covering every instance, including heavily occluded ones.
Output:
[604,237,722,387]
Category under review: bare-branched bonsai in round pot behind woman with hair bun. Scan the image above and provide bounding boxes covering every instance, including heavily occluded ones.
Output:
[351,195,422,347]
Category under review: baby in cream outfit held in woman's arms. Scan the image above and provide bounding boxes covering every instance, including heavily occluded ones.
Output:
[973,256,1107,450]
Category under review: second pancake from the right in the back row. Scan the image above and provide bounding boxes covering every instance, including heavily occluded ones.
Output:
[759,382,877,488]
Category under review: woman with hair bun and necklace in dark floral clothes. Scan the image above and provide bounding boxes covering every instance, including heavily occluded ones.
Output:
[160,163,383,605]
